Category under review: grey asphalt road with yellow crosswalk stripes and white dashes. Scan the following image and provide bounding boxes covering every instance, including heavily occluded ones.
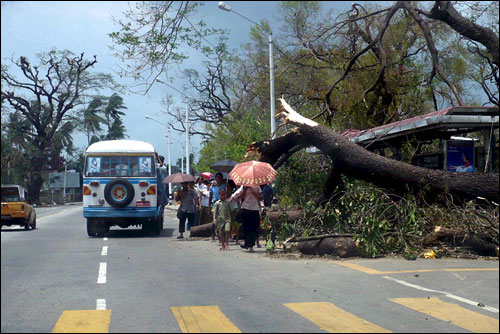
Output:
[1,205,499,333]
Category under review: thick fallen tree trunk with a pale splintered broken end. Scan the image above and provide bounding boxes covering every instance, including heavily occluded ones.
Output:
[247,99,500,203]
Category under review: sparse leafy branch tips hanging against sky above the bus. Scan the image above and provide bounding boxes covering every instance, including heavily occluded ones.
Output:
[108,1,228,79]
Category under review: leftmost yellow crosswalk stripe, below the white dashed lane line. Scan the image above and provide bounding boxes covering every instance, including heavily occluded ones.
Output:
[52,310,111,333]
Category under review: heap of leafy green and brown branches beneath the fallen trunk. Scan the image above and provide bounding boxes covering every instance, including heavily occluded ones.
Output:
[275,179,499,259]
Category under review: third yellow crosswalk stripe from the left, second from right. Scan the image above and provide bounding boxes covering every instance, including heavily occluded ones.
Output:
[283,302,391,333]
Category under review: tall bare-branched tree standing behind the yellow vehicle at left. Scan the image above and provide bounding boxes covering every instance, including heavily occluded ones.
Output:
[1,50,112,201]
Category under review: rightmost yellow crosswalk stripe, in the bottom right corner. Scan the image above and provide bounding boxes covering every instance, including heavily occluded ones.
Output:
[389,297,498,333]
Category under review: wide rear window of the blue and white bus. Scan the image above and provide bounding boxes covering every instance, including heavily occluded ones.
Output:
[85,155,155,177]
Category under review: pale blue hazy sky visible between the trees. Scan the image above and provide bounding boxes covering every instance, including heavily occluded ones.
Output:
[1,1,351,164]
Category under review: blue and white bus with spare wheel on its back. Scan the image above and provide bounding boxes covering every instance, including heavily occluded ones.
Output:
[83,140,163,236]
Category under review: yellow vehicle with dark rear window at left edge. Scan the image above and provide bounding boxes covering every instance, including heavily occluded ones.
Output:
[2,184,36,230]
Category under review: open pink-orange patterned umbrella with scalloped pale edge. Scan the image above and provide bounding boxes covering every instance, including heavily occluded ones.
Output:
[229,160,278,187]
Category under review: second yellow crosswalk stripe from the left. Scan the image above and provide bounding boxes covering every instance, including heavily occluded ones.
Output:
[171,306,241,333]
